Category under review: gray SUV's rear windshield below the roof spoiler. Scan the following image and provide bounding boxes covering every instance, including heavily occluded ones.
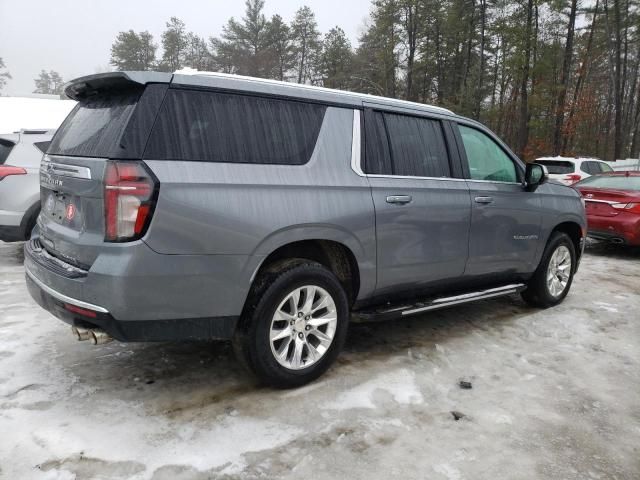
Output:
[49,91,141,157]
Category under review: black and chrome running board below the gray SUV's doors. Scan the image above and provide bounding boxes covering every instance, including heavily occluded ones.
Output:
[353,283,526,322]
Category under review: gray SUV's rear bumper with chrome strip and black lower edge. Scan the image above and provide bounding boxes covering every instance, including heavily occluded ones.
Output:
[25,240,260,341]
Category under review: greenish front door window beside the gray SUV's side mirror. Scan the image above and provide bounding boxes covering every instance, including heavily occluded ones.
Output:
[458,125,518,183]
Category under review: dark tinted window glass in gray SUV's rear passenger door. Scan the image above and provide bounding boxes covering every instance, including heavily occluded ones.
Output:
[384,113,451,177]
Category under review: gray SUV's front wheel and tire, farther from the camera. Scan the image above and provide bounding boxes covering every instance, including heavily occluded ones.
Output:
[522,232,576,308]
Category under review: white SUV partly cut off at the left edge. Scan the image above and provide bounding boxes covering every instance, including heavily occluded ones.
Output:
[0,130,55,242]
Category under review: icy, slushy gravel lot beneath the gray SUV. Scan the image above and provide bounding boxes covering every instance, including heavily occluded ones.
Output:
[0,242,640,480]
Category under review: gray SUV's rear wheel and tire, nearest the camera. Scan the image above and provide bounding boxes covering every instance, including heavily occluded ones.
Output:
[233,259,349,388]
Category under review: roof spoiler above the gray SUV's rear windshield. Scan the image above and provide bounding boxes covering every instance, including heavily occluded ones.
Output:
[64,72,173,100]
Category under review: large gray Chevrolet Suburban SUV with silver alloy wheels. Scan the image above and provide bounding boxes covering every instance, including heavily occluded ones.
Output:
[25,72,586,387]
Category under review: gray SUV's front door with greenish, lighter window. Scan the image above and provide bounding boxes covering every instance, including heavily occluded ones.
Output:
[458,124,542,277]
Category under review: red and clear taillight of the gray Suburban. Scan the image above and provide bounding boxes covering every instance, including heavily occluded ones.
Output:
[104,161,158,242]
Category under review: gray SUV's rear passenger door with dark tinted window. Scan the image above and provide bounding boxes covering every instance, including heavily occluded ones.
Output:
[364,110,471,294]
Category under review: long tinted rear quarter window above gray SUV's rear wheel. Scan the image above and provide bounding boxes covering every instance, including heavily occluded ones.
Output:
[145,90,326,165]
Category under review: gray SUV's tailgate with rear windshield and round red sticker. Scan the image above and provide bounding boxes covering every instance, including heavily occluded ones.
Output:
[38,83,167,268]
